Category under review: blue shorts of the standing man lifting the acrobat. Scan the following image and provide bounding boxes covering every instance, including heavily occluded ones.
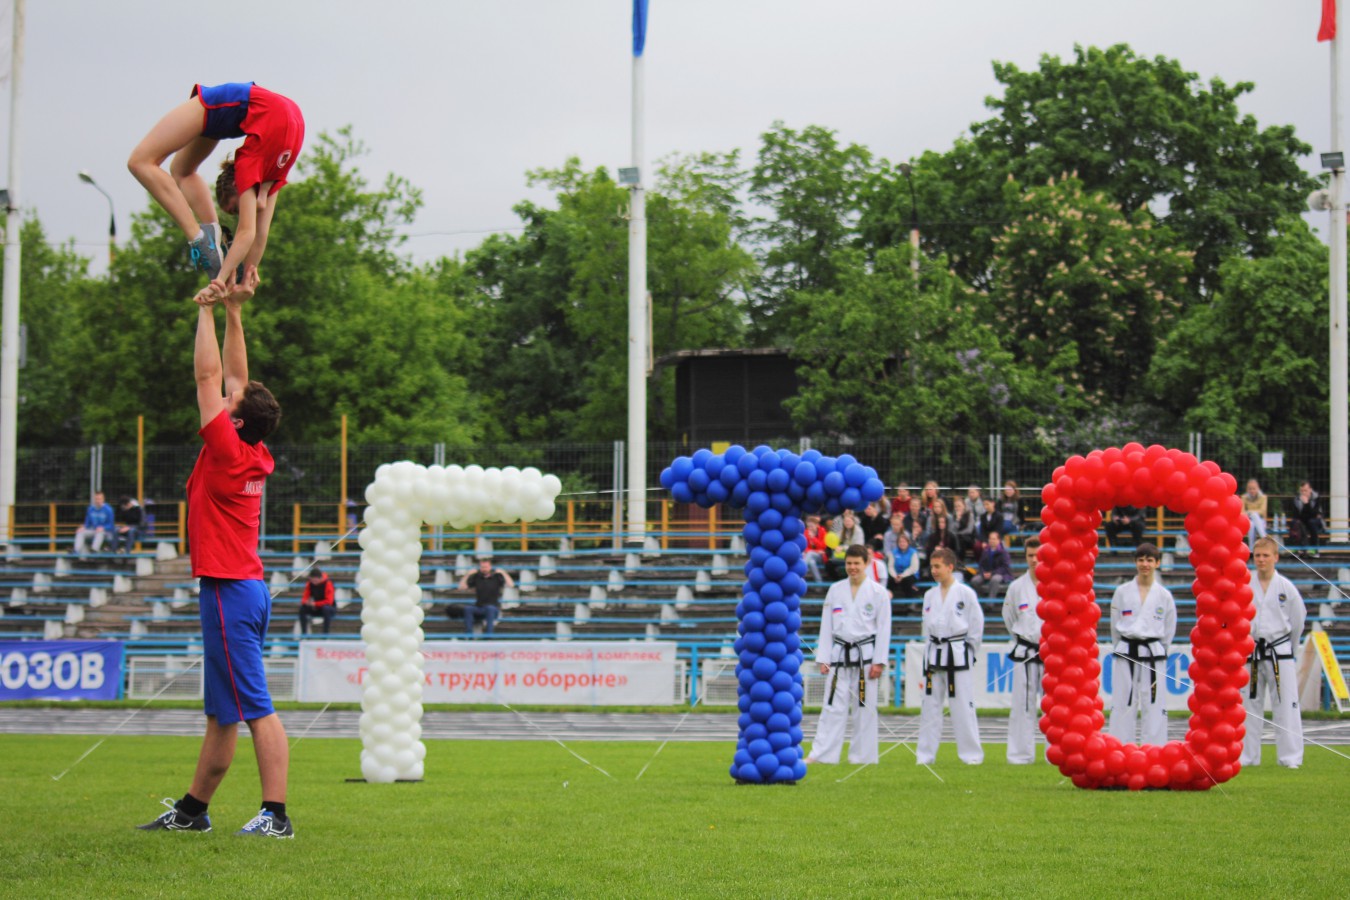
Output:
[198,578,274,725]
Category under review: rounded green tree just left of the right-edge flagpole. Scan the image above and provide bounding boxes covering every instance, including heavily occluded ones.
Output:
[1149,216,1328,437]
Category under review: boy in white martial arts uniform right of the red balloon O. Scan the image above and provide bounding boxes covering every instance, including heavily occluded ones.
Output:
[1242,537,1308,769]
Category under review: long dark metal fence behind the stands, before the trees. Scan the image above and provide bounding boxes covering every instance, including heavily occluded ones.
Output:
[16,433,1330,507]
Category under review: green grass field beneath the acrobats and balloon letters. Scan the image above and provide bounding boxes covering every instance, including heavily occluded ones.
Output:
[0,735,1350,897]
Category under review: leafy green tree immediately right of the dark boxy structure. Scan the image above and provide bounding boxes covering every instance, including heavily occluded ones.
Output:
[788,247,1081,436]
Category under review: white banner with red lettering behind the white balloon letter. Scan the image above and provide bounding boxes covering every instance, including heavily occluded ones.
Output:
[296,641,683,706]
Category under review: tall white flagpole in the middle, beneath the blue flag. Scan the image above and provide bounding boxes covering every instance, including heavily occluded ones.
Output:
[628,8,648,542]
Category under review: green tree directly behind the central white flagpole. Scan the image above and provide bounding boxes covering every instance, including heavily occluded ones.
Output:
[464,159,753,441]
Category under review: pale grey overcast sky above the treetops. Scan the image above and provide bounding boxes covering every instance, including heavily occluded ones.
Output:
[0,0,1331,273]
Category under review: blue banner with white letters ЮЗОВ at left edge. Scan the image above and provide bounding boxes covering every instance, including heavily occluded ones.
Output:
[0,641,122,700]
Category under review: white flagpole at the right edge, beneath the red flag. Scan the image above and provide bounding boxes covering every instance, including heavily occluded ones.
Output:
[1327,0,1350,541]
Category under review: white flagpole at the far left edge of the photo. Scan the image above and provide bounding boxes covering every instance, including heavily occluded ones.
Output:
[0,0,24,544]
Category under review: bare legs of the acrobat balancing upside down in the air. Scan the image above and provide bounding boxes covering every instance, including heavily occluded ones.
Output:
[127,99,217,240]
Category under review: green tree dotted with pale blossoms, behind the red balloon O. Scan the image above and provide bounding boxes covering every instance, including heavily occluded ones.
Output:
[990,177,1191,402]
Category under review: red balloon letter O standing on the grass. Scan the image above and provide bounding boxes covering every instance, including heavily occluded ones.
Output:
[1035,444,1254,791]
